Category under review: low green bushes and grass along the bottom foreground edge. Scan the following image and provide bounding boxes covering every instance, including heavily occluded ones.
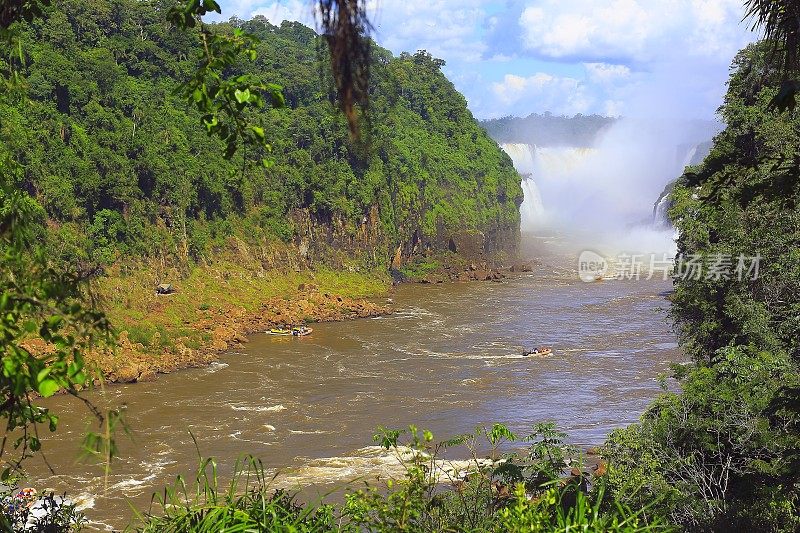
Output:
[137,424,669,533]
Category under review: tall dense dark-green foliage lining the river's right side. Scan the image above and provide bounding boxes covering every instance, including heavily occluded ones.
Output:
[607,43,800,531]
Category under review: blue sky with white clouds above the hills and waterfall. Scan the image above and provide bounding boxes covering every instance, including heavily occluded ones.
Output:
[220,0,756,119]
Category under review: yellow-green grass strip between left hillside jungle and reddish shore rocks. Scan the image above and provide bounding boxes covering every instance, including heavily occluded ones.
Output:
[93,244,390,374]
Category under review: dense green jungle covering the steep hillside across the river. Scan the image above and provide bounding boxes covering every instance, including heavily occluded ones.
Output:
[0,0,521,264]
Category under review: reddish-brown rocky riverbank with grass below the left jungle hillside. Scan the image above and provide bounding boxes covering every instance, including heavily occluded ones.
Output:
[56,254,531,383]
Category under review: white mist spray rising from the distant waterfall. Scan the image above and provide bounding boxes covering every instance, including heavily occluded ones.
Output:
[502,119,711,254]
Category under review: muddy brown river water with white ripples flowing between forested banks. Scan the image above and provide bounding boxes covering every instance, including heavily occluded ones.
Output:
[29,237,681,529]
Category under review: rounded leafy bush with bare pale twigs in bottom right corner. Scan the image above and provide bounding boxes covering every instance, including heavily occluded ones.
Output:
[604,348,800,531]
